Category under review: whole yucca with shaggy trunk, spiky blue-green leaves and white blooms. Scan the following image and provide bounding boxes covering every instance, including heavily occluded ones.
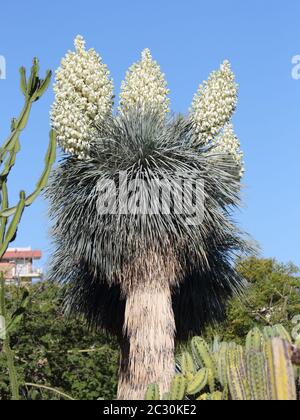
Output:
[47,37,249,399]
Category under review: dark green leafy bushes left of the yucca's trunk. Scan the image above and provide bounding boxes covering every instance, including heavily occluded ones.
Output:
[0,283,119,400]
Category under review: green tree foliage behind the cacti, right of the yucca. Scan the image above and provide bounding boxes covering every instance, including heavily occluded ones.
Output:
[204,257,300,343]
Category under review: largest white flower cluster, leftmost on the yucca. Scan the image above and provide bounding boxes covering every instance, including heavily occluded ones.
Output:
[51,36,113,159]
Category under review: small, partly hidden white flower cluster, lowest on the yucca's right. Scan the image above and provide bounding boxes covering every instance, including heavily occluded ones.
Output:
[214,124,245,178]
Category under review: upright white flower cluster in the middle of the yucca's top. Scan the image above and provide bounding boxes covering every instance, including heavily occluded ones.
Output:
[119,49,170,118]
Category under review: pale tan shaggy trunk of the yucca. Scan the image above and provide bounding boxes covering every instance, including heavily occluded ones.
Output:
[118,279,175,400]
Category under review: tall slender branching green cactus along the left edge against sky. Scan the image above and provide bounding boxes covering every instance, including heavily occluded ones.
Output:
[0,58,56,400]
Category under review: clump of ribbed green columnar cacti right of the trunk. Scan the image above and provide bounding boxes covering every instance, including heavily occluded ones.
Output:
[145,325,300,401]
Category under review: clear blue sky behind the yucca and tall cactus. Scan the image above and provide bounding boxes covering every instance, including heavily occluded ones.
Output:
[0,0,300,265]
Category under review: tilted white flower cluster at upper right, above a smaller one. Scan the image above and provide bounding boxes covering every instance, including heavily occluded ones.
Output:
[191,61,238,142]
